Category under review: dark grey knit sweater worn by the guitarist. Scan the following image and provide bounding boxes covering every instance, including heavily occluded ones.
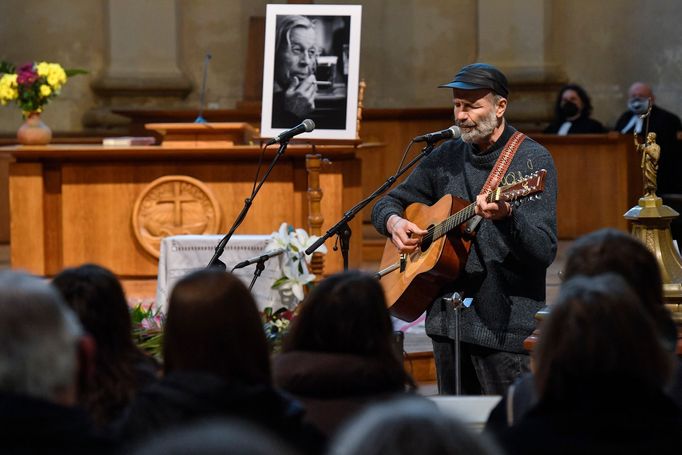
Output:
[372,126,557,352]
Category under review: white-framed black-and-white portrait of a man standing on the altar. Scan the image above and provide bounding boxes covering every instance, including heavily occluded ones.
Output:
[260,4,362,140]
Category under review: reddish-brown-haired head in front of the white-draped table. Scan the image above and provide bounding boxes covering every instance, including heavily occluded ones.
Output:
[163,269,271,384]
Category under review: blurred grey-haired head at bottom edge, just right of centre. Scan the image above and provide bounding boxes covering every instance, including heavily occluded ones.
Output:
[330,398,501,455]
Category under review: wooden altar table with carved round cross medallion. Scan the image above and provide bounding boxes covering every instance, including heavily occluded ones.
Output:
[0,143,362,279]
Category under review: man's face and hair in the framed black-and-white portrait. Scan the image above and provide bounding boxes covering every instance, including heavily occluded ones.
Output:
[275,15,319,90]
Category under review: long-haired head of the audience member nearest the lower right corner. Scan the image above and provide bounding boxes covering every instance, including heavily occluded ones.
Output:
[535,274,672,403]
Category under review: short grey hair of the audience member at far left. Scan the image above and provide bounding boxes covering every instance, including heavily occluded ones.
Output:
[0,271,83,400]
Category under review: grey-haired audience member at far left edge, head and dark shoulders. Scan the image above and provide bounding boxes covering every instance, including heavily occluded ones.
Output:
[0,271,114,454]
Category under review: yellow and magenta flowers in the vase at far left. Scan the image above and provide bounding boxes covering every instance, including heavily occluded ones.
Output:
[0,62,86,117]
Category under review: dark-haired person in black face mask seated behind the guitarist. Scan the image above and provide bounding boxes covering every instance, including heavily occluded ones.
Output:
[544,84,606,136]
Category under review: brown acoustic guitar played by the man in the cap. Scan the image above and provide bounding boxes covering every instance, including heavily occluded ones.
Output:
[377,169,547,322]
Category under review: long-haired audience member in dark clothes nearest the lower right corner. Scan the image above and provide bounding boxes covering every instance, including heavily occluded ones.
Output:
[498,274,682,455]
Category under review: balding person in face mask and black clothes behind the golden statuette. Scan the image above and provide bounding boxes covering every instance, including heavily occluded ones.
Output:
[614,82,682,196]
